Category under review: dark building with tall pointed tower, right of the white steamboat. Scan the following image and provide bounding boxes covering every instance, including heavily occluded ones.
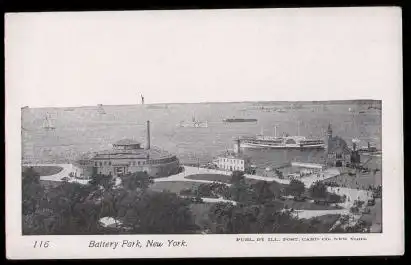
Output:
[325,124,360,167]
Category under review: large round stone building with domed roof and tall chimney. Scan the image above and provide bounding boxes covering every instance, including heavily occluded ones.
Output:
[75,121,180,178]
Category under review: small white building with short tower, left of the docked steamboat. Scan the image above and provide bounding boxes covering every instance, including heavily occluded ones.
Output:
[215,139,251,172]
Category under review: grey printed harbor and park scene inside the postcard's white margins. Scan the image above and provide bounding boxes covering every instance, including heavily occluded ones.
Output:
[22,99,383,235]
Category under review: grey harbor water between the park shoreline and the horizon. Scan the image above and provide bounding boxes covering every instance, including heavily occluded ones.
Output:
[22,102,381,167]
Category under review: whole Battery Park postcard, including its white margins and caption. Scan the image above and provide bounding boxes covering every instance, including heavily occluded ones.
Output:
[5,7,403,258]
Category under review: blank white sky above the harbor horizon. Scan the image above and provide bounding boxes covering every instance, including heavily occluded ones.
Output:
[5,7,402,107]
